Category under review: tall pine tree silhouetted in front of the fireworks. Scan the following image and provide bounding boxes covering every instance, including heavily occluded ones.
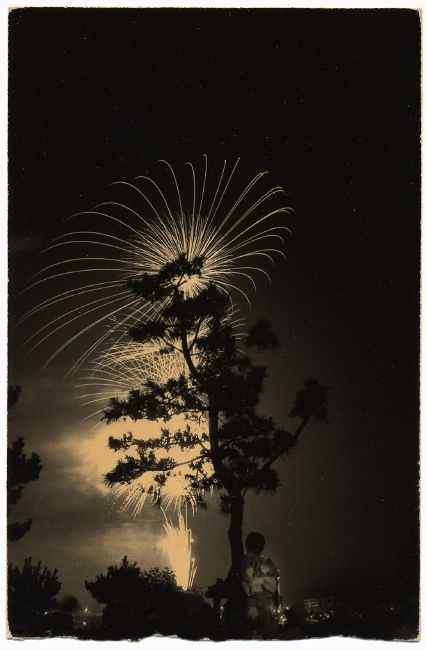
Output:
[103,254,328,565]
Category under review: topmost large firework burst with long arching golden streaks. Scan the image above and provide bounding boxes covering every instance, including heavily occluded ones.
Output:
[17,156,290,374]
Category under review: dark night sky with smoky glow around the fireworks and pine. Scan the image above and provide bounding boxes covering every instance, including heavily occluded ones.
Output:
[9,9,420,607]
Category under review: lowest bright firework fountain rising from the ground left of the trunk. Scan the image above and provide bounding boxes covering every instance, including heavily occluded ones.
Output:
[158,510,196,589]
